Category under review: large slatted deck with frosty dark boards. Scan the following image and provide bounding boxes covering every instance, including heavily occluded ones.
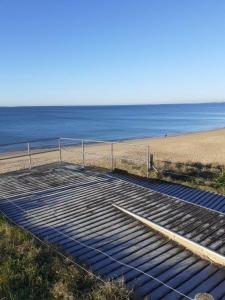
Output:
[0,166,225,299]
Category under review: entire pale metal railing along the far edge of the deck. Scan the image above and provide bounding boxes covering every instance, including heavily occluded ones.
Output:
[0,137,151,177]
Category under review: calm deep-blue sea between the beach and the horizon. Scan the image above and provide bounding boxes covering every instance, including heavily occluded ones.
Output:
[0,103,225,144]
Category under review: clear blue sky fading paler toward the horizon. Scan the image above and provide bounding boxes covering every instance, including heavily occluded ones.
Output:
[0,0,225,106]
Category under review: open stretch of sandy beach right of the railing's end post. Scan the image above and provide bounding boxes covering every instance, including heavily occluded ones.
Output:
[137,128,225,165]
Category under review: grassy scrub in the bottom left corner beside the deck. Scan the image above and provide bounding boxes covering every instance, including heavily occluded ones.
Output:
[0,216,133,300]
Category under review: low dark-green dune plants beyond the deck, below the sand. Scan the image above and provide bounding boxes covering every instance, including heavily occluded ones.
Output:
[114,160,225,195]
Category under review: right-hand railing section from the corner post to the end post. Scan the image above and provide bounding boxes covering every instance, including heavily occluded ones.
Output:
[60,138,150,176]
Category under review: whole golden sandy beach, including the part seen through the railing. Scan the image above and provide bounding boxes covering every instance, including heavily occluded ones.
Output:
[0,129,225,172]
